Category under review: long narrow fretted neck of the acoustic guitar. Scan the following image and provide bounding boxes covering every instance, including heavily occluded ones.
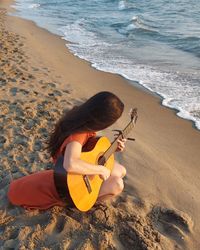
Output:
[103,120,136,161]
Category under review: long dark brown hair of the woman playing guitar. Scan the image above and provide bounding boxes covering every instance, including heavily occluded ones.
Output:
[47,91,124,156]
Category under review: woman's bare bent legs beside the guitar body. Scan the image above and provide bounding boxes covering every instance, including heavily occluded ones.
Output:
[98,162,126,201]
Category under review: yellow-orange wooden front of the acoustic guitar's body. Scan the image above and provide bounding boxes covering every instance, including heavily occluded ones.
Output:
[67,137,114,211]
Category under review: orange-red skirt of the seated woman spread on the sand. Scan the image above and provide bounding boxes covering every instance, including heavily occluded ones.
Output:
[8,170,66,210]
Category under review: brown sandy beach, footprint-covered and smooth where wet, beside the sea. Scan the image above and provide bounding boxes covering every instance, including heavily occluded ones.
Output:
[0,0,200,250]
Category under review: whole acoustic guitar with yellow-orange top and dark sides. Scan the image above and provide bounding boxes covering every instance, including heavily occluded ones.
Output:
[54,109,138,212]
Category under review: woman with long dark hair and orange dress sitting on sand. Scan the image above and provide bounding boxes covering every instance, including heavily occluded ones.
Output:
[8,92,126,210]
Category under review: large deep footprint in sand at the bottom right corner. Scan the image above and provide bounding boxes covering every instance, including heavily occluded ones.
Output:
[150,206,193,245]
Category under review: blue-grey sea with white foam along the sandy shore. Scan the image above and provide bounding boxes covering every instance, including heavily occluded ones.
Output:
[10,0,200,129]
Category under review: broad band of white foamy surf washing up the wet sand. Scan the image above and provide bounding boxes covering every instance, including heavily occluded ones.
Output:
[61,25,200,130]
